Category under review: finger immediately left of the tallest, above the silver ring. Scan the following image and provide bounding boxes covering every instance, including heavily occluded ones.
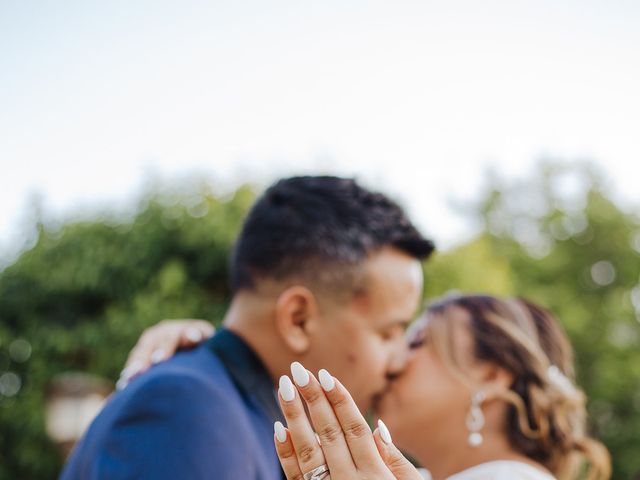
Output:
[278,375,326,472]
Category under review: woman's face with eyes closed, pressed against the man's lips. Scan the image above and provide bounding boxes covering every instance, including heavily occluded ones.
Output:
[377,307,477,456]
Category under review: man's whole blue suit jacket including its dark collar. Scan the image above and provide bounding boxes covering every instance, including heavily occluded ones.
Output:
[61,330,282,480]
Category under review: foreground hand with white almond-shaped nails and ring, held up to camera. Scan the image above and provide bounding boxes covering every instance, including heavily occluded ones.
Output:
[274,362,422,480]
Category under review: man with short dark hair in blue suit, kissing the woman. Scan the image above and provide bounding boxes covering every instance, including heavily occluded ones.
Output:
[61,177,433,480]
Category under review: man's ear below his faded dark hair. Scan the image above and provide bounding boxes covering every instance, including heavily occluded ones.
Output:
[275,285,318,354]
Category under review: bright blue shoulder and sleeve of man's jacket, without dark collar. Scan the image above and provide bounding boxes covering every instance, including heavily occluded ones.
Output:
[62,347,274,479]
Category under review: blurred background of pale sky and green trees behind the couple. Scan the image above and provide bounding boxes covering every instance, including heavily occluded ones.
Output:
[0,0,640,480]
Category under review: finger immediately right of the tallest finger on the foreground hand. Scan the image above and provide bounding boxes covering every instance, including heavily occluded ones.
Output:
[319,370,383,470]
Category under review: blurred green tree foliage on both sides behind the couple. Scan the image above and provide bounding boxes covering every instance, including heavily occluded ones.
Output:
[0,164,640,480]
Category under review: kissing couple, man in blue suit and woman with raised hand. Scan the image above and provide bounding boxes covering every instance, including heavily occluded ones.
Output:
[61,176,610,480]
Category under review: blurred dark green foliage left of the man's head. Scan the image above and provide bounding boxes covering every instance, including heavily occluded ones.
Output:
[0,188,254,480]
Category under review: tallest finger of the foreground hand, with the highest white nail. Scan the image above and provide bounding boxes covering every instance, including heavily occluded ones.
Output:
[291,362,357,478]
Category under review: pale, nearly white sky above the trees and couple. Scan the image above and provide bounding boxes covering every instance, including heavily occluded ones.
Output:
[0,0,640,262]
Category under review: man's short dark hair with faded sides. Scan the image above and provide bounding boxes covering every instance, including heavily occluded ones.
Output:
[231,176,434,294]
